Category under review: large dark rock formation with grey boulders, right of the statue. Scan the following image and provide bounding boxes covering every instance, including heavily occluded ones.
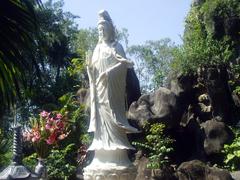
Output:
[128,67,237,163]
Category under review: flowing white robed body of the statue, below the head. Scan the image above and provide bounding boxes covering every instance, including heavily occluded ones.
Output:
[88,42,138,150]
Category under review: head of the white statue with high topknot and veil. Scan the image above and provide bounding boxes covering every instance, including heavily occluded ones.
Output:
[98,10,115,42]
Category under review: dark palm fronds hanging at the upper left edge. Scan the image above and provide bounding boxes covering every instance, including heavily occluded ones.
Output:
[0,0,41,108]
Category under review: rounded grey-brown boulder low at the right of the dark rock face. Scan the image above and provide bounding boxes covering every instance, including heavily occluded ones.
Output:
[201,119,233,155]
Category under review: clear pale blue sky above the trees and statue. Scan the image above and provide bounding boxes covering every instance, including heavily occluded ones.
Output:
[57,0,192,45]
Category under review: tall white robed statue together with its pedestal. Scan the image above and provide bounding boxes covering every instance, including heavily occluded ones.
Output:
[84,10,138,179]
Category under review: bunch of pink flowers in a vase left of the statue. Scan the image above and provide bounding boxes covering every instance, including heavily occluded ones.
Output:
[23,111,69,158]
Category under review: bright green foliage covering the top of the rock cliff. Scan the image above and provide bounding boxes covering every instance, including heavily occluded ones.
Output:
[172,0,240,73]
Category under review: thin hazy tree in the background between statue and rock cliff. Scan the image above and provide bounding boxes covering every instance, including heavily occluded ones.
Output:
[128,38,175,91]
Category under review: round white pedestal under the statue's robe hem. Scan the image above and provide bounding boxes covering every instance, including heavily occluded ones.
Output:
[83,149,137,180]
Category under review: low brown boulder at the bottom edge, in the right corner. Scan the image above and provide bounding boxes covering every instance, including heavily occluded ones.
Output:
[176,160,233,180]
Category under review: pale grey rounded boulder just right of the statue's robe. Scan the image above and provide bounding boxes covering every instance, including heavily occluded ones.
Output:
[128,87,181,127]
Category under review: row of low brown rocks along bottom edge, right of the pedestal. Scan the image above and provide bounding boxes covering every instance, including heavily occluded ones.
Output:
[135,156,233,180]
